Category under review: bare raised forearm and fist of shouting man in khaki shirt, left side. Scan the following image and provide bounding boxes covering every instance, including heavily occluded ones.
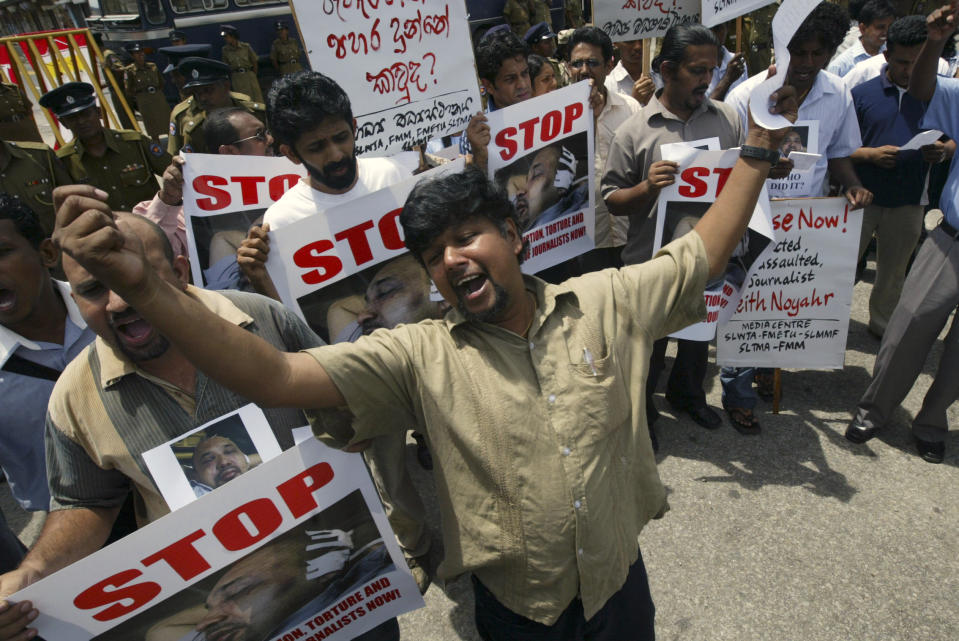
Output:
[54,185,345,409]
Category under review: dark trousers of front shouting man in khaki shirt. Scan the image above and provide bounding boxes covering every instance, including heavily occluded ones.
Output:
[473,554,656,641]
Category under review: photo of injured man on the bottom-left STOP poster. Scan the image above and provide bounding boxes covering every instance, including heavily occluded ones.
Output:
[94,490,399,641]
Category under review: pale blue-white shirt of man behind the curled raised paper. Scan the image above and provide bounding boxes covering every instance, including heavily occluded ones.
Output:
[726,71,862,196]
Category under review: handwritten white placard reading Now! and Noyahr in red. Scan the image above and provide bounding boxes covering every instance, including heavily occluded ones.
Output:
[716,198,862,369]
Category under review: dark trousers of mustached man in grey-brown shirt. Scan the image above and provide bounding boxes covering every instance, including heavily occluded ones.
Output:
[646,338,709,408]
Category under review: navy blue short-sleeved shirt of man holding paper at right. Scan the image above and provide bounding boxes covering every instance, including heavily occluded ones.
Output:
[852,69,929,207]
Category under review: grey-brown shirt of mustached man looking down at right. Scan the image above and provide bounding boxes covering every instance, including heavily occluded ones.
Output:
[602,95,744,263]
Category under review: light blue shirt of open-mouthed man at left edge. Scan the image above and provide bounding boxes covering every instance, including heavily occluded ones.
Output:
[0,280,94,510]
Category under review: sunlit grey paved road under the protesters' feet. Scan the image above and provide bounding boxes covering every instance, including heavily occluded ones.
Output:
[0,262,959,641]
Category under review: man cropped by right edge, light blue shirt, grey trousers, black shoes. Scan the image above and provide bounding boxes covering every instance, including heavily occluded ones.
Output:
[846,2,959,463]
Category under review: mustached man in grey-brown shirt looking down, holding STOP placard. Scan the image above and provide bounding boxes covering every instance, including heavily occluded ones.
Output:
[602,25,743,438]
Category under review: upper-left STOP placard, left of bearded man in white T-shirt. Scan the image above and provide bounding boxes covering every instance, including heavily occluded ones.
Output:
[183,154,306,289]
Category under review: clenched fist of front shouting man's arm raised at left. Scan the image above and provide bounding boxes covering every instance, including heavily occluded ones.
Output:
[53,185,150,296]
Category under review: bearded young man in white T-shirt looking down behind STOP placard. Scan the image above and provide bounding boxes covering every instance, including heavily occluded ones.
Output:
[237,71,430,592]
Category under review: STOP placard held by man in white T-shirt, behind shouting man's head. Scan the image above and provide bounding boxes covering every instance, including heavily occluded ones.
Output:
[266,159,464,342]
